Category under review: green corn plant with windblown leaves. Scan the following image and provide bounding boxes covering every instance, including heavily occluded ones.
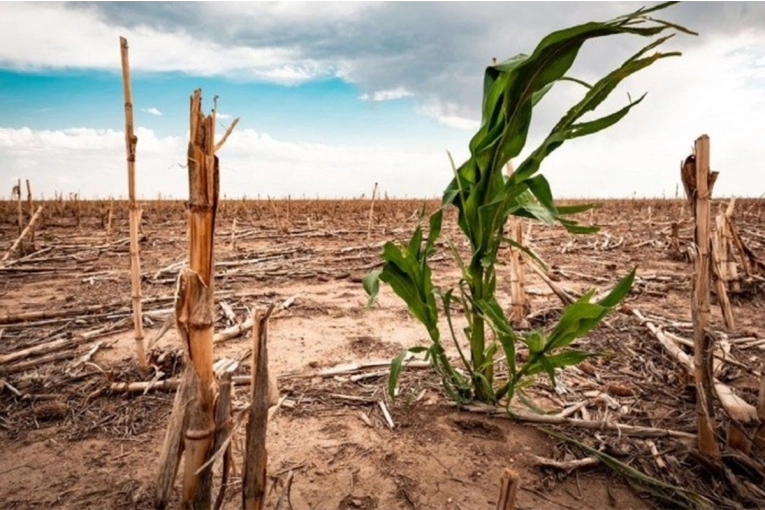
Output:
[363,1,693,403]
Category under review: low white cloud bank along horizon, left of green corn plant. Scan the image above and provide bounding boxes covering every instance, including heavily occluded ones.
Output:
[0,126,449,198]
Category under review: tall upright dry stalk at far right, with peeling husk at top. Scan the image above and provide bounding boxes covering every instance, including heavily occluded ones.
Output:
[686,135,720,459]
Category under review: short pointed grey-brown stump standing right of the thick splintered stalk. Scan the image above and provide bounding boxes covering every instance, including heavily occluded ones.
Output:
[242,306,273,510]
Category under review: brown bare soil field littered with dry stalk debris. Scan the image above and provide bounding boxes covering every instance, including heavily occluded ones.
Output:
[0,200,765,510]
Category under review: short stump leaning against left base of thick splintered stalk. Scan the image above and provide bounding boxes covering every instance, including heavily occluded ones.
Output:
[154,366,194,508]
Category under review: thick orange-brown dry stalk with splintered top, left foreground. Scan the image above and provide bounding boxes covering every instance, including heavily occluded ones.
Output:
[180,90,219,509]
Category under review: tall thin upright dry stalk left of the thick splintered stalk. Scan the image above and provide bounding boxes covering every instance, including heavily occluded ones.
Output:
[119,37,146,367]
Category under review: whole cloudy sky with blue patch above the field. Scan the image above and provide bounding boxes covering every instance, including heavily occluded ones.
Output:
[0,0,765,198]
